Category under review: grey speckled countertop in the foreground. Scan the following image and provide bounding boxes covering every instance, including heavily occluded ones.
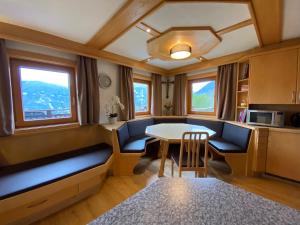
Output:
[89,178,300,225]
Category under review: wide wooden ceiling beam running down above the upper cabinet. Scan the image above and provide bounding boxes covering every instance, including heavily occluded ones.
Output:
[251,0,283,45]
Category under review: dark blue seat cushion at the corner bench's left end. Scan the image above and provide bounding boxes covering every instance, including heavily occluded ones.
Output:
[121,135,154,153]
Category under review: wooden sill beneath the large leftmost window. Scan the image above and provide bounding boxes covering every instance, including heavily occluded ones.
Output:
[14,123,80,135]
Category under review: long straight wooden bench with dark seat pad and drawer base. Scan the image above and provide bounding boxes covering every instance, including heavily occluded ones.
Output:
[0,143,113,224]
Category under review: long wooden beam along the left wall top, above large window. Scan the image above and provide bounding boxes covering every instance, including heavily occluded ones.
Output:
[0,22,166,75]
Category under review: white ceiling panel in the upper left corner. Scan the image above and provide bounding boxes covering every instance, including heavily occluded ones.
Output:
[0,0,126,43]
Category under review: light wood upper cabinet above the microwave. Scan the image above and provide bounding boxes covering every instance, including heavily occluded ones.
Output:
[249,49,300,104]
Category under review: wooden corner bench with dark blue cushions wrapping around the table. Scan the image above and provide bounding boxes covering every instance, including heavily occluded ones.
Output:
[114,117,251,175]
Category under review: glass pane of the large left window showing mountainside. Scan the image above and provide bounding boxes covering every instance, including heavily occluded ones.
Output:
[20,67,71,121]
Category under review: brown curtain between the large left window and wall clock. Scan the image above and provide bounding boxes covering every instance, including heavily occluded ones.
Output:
[77,56,100,125]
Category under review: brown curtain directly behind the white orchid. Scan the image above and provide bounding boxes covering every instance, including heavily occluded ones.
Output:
[119,65,134,120]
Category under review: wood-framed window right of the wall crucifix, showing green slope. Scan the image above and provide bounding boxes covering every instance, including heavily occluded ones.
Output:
[188,77,216,115]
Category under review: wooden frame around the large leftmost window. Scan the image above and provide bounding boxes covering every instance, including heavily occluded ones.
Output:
[10,58,78,128]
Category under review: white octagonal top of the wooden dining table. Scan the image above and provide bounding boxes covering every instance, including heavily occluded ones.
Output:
[145,123,216,142]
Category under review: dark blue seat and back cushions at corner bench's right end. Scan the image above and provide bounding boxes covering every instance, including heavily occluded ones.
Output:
[208,123,251,153]
